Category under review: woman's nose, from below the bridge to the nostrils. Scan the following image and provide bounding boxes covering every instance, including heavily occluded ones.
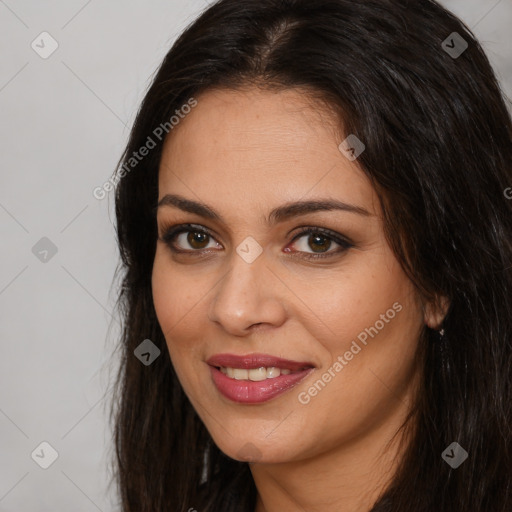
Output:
[208,252,287,336]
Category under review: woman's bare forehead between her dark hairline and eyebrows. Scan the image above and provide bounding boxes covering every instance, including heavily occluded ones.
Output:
[159,88,377,218]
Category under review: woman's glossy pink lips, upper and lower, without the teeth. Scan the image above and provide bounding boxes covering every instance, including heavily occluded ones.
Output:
[207,354,314,404]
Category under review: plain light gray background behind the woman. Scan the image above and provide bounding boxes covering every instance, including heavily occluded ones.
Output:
[0,0,512,512]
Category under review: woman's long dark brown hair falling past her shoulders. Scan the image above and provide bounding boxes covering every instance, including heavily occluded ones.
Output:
[111,0,512,512]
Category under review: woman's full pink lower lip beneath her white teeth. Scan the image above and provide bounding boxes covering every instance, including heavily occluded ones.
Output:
[210,366,314,404]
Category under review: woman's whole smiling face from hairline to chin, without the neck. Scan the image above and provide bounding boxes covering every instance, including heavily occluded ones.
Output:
[152,88,428,462]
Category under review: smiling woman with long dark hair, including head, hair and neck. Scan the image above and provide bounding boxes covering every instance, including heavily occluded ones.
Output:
[109,0,512,512]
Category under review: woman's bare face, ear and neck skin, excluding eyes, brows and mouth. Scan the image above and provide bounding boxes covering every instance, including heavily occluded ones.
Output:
[152,87,442,512]
